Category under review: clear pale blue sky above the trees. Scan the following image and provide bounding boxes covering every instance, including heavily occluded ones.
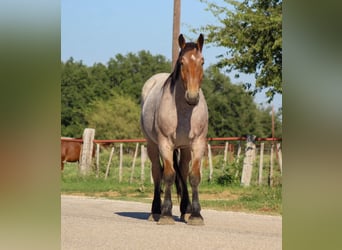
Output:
[61,0,282,109]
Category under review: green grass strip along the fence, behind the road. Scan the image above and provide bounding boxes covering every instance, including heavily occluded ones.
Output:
[61,146,282,215]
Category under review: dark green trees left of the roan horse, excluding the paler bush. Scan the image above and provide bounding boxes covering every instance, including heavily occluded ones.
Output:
[61,51,171,137]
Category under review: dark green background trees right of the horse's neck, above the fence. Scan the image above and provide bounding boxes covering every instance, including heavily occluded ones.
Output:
[202,66,262,137]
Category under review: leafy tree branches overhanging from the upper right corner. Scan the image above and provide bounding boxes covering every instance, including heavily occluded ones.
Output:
[202,0,282,102]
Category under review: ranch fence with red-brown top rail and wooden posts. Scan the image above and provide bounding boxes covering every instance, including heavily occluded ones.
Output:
[61,129,282,186]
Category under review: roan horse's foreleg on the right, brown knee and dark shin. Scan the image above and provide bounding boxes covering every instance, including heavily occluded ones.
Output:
[188,143,206,225]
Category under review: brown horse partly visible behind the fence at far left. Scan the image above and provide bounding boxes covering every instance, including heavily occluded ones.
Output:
[61,138,96,171]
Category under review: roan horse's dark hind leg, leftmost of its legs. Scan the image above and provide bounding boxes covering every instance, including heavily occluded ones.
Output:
[147,142,162,221]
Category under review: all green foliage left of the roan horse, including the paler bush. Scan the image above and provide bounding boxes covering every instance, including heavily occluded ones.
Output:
[61,51,171,139]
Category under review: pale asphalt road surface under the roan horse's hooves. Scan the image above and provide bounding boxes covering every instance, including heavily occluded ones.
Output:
[61,195,282,250]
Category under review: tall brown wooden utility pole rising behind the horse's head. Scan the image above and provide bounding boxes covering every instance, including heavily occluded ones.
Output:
[171,0,181,71]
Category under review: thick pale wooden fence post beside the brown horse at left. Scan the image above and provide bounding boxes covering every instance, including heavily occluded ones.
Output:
[79,128,95,175]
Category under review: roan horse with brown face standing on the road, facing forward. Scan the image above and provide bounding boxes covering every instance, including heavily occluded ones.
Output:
[140,34,208,225]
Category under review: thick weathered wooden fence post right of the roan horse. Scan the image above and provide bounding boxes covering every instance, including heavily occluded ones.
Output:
[241,136,255,187]
